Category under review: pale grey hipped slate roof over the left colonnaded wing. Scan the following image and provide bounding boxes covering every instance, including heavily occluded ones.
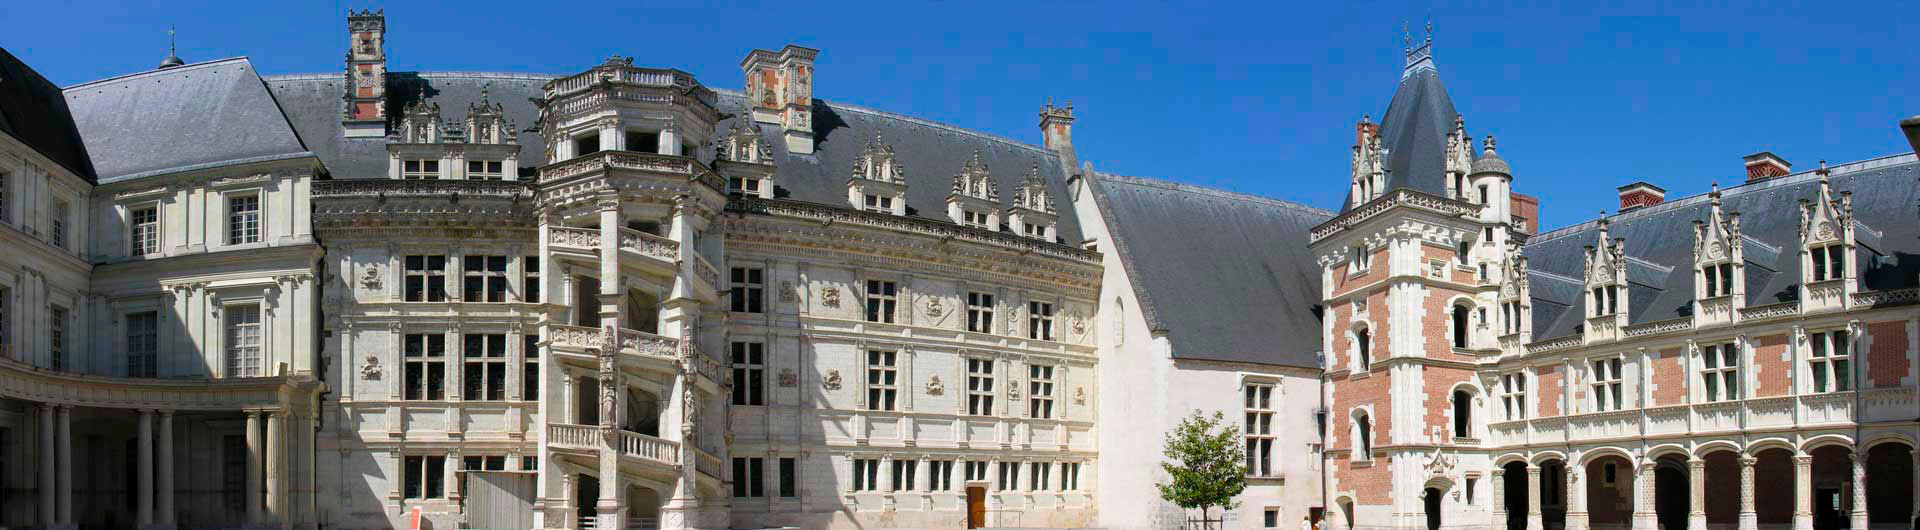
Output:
[65,58,311,182]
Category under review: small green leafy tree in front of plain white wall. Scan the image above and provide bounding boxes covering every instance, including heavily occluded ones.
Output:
[1154,411,1246,518]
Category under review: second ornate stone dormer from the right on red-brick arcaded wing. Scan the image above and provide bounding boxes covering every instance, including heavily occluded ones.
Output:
[1693,184,1747,326]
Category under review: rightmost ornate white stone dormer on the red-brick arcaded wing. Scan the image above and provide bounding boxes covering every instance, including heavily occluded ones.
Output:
[1799,159,1859,311]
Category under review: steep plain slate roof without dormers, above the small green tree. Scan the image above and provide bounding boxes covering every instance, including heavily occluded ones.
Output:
[1089,173,1334,369]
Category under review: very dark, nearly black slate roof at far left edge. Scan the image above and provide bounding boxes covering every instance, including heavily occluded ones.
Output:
[0,48,94,182]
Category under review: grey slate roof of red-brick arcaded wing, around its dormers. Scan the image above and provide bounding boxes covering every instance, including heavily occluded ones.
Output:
[1524,154,1920,340]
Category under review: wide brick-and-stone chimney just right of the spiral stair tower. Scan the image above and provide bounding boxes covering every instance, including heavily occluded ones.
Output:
[739,44,820,154]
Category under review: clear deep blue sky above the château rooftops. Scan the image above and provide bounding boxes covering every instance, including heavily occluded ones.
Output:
[0,2,1920,229]
